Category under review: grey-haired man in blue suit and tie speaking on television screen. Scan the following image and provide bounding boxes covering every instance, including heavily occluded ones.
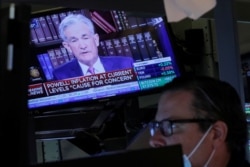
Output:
[53,14,134,80]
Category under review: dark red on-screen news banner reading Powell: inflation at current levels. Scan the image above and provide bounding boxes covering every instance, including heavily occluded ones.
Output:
[28,69,136,98]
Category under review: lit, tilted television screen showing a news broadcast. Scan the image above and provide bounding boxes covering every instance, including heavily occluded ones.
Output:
[28,8,180,111]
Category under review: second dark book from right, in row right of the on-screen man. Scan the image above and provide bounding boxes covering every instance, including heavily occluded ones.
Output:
[135,33,151,60]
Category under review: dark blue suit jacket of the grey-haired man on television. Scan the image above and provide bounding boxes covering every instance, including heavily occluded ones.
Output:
[53,56,134,80]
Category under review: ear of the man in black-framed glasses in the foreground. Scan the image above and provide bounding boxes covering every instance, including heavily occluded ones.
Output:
[213,121,228,147]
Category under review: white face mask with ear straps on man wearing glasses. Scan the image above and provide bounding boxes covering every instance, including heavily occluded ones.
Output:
[183,126,215,167]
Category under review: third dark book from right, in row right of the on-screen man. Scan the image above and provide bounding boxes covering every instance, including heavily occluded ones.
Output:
[128,34,143,62]
